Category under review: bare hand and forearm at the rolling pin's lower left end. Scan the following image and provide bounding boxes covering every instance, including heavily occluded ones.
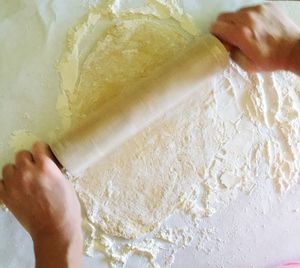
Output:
[0,143,82,268]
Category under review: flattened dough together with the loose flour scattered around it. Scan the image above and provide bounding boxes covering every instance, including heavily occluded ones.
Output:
[55,1,300,266]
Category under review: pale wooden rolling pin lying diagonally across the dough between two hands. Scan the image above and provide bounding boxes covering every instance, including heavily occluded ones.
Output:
[51,35,229,176]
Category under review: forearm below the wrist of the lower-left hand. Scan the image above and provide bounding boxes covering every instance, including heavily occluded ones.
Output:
[34,232,83,268]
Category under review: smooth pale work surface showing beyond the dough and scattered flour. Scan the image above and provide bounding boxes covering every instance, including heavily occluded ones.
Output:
[0,0,300,268]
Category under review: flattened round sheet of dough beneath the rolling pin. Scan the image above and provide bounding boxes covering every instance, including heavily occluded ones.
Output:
[60,1,199,241]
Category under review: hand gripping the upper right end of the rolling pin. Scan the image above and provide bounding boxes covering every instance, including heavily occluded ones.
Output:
[211,3,300,72]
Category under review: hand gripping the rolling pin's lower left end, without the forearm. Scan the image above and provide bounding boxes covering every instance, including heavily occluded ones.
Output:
[0,143,81,245]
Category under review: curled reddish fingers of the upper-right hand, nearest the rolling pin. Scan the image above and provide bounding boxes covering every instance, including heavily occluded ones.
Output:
[211,21,257,58]
